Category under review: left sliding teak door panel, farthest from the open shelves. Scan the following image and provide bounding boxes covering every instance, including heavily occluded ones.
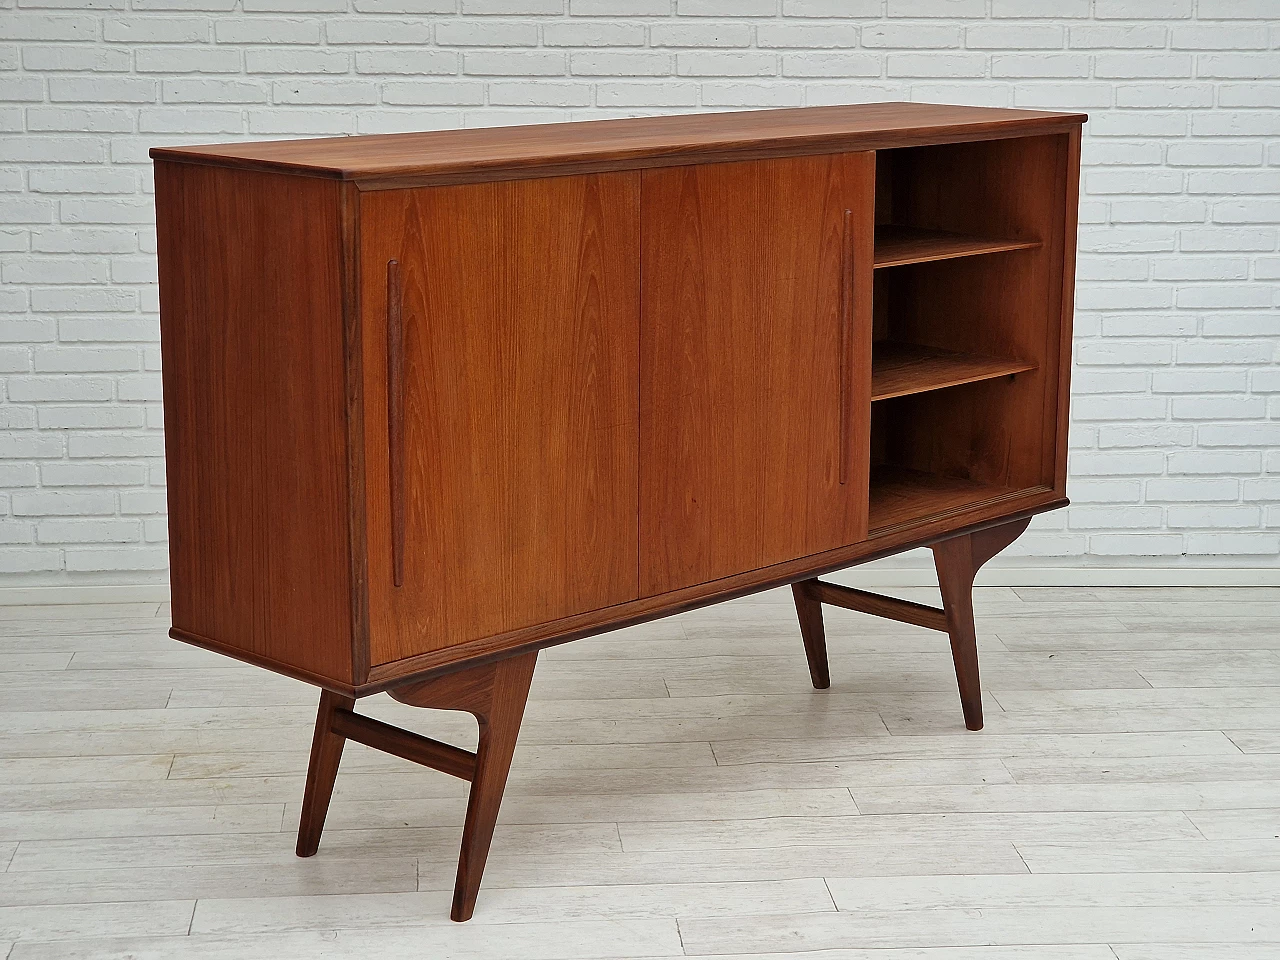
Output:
[362,174,639,664]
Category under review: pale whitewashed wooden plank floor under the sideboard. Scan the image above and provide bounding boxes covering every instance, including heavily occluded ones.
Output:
[0,588,1280,960]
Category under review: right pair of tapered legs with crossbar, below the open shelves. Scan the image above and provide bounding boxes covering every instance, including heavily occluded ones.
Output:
[791,518,1030,730]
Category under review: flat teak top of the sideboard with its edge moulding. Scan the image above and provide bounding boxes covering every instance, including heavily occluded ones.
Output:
[151,102,1087,182]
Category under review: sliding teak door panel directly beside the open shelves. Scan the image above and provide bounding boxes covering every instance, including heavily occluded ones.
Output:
[640,154,873,595]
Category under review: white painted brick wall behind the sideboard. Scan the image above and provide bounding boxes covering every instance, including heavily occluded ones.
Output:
[0,0,1280,585]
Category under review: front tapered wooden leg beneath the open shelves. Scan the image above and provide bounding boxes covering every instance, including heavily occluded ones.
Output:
[933,520,1030,730]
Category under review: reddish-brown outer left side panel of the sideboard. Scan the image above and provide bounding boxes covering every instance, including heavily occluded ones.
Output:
[156,161,352,684]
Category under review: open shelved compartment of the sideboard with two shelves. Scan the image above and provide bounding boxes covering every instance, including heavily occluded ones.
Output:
[869,136,1068,536]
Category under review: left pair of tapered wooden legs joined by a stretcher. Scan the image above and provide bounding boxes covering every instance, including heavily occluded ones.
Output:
[297,652,538,920]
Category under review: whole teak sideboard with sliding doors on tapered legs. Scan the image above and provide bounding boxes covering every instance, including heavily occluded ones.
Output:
[151,104,1085,920]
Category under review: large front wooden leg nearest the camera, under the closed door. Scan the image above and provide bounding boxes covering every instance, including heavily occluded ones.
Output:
[389,653,538,922]
